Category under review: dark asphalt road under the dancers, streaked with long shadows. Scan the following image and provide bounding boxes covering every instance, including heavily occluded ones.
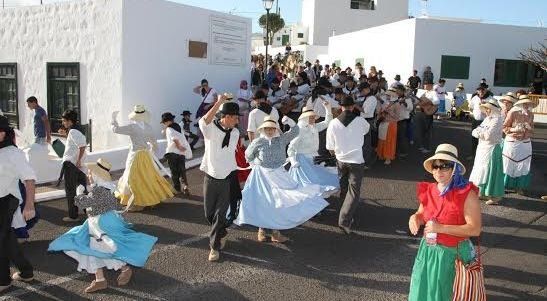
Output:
[0,121,547,301]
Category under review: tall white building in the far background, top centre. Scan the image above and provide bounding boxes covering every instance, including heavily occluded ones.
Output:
[302,0,408,45]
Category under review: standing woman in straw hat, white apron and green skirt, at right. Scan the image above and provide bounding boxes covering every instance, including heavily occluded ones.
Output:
[469,98,505,205]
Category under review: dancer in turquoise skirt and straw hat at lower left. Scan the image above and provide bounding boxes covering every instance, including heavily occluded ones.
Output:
[48,159,157,293]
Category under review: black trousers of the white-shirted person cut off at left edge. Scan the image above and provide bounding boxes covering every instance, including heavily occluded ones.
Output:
[0,194,34,286]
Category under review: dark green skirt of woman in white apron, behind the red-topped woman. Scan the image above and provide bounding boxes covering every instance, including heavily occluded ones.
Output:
[479,144,505,198]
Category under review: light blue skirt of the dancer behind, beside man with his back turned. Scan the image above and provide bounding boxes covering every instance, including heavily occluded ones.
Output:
[289,154,340,193]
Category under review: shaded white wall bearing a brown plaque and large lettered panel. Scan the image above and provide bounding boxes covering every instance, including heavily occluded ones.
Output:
[119,0,251,145]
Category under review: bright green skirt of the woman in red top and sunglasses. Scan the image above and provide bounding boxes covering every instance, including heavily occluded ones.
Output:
[408,239,474,301]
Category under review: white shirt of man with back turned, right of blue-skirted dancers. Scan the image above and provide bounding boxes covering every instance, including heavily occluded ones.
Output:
[327,116,370,164]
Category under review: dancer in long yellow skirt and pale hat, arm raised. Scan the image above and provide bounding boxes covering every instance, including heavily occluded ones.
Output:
[112,105,174,211]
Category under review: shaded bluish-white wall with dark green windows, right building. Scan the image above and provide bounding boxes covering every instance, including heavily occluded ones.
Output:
[414,18,547,94]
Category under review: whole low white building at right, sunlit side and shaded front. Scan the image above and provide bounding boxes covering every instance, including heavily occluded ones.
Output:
[328,18,547,94]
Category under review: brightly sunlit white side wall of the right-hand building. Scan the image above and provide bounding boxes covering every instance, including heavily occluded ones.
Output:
[328,19,415,83]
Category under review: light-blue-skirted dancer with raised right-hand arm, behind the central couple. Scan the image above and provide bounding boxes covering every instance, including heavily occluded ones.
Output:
[287,101,340,196]
